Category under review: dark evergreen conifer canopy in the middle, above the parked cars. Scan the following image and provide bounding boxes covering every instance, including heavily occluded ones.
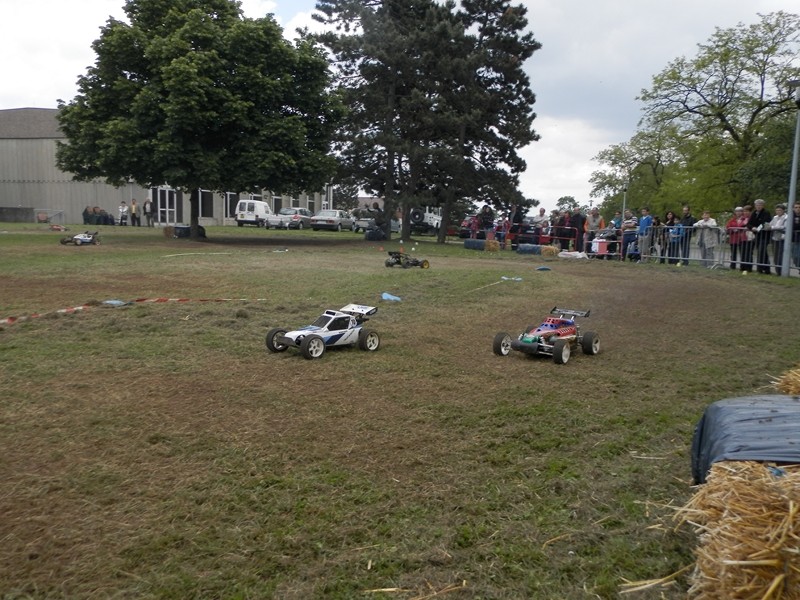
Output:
[317,0,540,239]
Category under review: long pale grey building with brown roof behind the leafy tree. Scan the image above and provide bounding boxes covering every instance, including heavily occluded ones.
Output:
[0,108,330,226]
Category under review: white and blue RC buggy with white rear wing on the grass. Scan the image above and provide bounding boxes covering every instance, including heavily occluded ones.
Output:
[267,304,381,360]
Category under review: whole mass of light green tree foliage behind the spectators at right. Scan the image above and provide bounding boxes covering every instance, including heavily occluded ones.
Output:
[591,12,800,218]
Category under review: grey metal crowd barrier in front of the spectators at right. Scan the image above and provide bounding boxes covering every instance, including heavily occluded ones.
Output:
[585,226,800,275]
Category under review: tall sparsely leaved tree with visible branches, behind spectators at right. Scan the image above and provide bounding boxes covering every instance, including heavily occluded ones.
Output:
[640,12,800,204]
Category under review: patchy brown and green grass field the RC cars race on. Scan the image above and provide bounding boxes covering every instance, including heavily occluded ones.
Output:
[0,224,800,600]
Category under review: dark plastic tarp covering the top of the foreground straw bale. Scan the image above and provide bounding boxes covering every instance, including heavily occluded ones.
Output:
[692,395,800,484]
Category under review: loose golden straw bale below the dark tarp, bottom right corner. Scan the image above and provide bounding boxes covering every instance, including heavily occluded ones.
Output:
[675,461,800,600]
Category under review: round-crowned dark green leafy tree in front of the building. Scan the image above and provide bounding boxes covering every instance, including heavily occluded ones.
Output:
[57,0,342,236]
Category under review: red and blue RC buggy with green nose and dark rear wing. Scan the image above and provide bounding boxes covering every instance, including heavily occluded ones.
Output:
[492,307,600,365]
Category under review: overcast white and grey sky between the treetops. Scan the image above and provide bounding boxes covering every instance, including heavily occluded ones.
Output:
[0,0,788,208]
